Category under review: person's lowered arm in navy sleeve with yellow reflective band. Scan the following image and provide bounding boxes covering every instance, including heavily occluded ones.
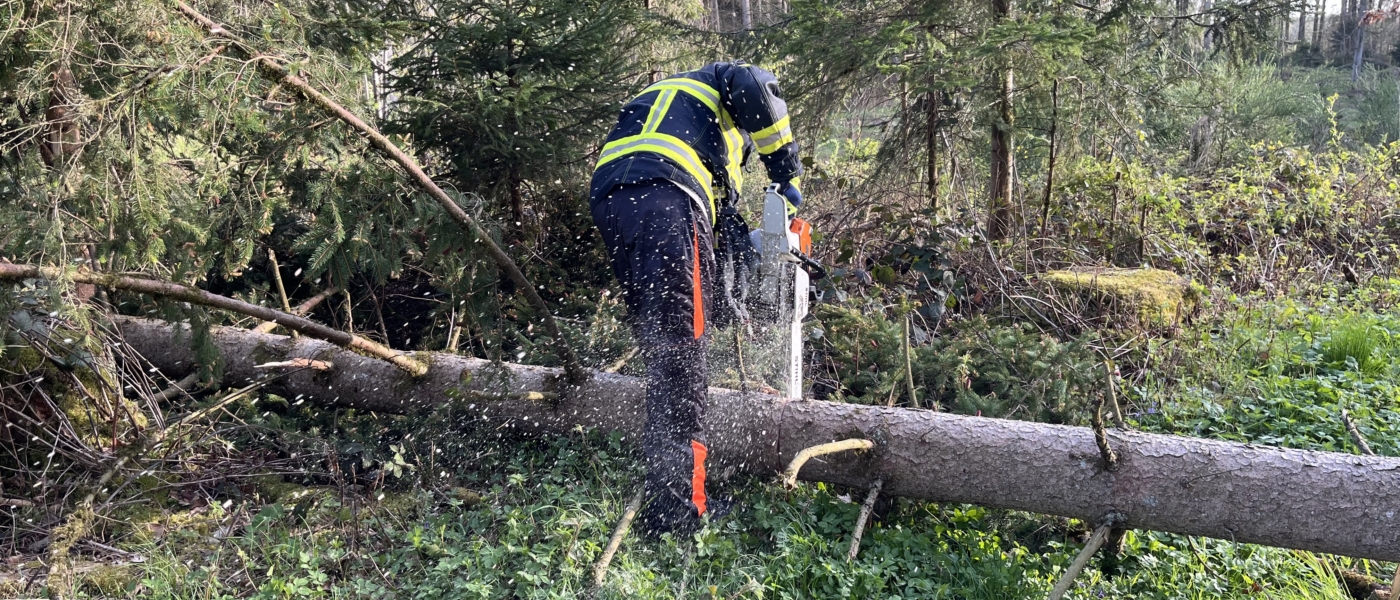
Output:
[720,63,802,208]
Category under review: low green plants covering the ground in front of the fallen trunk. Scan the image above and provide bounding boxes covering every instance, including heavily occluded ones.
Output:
[106,425,1366,600]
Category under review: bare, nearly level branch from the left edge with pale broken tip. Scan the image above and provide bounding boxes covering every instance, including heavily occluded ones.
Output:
[0,263,428,376]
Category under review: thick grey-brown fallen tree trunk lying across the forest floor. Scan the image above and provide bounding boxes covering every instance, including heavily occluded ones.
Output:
[118,317,1400,561]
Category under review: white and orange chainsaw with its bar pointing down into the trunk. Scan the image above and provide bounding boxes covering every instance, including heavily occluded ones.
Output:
[759,183,811,400]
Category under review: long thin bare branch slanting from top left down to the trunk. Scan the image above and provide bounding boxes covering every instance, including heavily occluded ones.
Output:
[175,0,589,383]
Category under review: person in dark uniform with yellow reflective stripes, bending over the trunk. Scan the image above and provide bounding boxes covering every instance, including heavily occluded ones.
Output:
[589,63,802,534]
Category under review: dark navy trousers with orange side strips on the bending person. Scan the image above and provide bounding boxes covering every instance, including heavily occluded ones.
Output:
[589,179,714,533]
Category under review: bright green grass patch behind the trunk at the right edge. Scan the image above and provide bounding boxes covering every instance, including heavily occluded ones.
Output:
[1133,283,1400,456]
